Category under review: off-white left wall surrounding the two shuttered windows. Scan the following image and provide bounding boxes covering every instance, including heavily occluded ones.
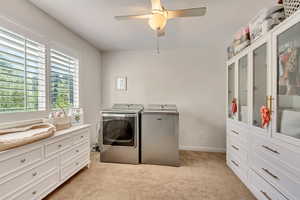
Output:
[0,0,101,144]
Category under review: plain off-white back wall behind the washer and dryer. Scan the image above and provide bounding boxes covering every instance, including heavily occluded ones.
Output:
[102,45,226,151]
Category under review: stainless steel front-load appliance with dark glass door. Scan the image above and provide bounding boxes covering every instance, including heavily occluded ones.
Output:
[99,104,143,164]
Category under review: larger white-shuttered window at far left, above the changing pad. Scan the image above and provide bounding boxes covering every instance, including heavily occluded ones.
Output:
[0,28,46,113]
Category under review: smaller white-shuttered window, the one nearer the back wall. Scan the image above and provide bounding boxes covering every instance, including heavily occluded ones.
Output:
[50,49,79,109]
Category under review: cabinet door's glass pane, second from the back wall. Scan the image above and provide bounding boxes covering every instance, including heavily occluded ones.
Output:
[238,55,249,123]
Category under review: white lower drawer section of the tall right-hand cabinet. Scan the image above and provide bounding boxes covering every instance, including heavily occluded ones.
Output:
[227,121,300,200]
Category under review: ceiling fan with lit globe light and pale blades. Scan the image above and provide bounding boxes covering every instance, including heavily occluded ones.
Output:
[115,0,207,37]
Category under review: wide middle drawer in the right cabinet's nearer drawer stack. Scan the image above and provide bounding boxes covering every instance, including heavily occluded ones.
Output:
[252,154,300,199]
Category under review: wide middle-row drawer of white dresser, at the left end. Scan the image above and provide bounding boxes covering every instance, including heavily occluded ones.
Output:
[0,157,59,200]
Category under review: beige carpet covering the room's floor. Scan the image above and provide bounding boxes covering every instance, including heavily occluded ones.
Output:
[46,151,255,200]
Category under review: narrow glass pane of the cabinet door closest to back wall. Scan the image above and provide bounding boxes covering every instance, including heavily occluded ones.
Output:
[227,63,235,119]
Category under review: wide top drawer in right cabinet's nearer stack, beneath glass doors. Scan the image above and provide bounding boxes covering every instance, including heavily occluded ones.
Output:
[252,136,300,175]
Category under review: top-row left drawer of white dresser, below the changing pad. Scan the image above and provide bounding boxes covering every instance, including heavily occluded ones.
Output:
[0,146,43,177]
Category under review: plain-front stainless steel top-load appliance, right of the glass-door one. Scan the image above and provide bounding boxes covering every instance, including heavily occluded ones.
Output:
[141,105,180,166]
